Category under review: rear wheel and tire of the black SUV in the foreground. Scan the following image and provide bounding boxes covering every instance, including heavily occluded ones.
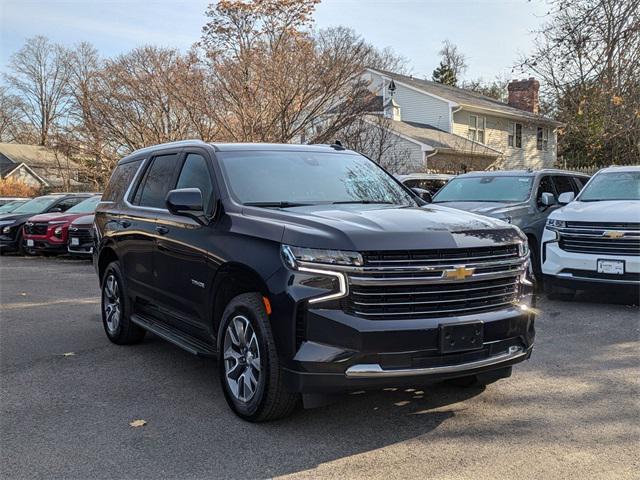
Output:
[100,262,146,345]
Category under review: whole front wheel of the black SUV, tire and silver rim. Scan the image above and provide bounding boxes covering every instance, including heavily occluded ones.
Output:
[218,293,300,422]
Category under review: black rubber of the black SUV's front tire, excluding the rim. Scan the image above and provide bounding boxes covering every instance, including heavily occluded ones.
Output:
[218,293,300,422]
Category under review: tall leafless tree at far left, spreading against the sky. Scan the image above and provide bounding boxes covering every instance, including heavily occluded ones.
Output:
[5,36,69,145]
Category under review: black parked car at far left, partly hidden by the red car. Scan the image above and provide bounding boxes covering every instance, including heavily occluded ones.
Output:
[0,193,92,253]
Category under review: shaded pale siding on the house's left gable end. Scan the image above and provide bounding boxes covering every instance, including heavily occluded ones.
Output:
[365,73,451,132]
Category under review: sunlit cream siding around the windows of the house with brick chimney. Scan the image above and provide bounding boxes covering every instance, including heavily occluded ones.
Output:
[453,110,557,169]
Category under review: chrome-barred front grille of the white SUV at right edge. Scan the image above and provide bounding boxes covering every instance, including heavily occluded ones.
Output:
[555,222,640,256]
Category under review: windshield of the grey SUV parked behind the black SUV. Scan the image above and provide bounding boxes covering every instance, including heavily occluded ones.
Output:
[433,175,533,203]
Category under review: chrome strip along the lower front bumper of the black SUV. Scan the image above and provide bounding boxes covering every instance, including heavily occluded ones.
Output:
[345,346,527,378]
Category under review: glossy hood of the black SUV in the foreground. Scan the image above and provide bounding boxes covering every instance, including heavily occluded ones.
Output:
[238,205,521,251]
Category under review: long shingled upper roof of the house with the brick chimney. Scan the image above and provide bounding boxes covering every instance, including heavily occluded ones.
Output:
[370,69,563,126]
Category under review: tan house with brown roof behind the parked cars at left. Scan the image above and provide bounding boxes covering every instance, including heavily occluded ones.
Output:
[0,143,86,191]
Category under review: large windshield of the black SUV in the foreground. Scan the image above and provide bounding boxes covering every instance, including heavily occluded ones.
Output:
[218,151,416,207]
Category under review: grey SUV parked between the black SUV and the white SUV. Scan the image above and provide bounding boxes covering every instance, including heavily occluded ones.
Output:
[433,169,589,278]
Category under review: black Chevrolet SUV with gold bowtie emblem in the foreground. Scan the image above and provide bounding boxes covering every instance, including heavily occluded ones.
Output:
[94,141,535,421]
